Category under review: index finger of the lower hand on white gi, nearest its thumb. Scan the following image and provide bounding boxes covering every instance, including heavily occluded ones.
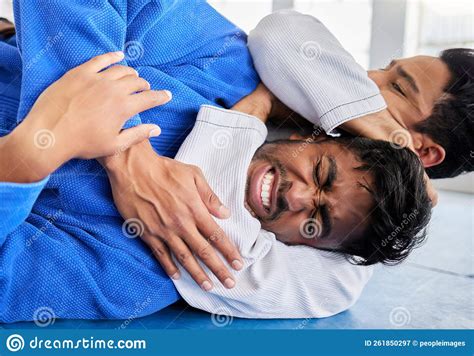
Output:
[197,212,243,271]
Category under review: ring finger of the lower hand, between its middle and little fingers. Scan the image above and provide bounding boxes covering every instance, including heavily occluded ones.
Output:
[165,236,213,291]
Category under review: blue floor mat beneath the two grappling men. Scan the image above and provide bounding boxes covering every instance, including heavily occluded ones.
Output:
[2,192,474,329]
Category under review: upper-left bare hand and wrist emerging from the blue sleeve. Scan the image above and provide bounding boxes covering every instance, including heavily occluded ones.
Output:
[0,53,167,183]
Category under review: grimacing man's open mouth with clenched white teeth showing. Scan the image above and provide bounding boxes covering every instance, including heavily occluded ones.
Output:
[247,164,280,218]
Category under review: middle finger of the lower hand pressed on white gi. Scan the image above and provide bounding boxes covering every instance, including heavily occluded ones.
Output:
[183,225,235,289]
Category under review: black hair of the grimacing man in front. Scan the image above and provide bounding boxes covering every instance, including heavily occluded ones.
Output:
[337,137,432,265]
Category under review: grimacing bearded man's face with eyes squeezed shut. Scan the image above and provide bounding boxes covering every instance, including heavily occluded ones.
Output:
[246,140,374,250]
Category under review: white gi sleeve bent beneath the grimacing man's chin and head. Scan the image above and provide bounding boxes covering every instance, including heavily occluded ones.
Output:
[173,106,372,318]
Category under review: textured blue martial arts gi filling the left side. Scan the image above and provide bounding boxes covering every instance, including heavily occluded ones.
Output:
[0,0,258,322]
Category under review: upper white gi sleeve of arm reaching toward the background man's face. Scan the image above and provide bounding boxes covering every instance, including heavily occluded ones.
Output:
[248,10,386,133]
